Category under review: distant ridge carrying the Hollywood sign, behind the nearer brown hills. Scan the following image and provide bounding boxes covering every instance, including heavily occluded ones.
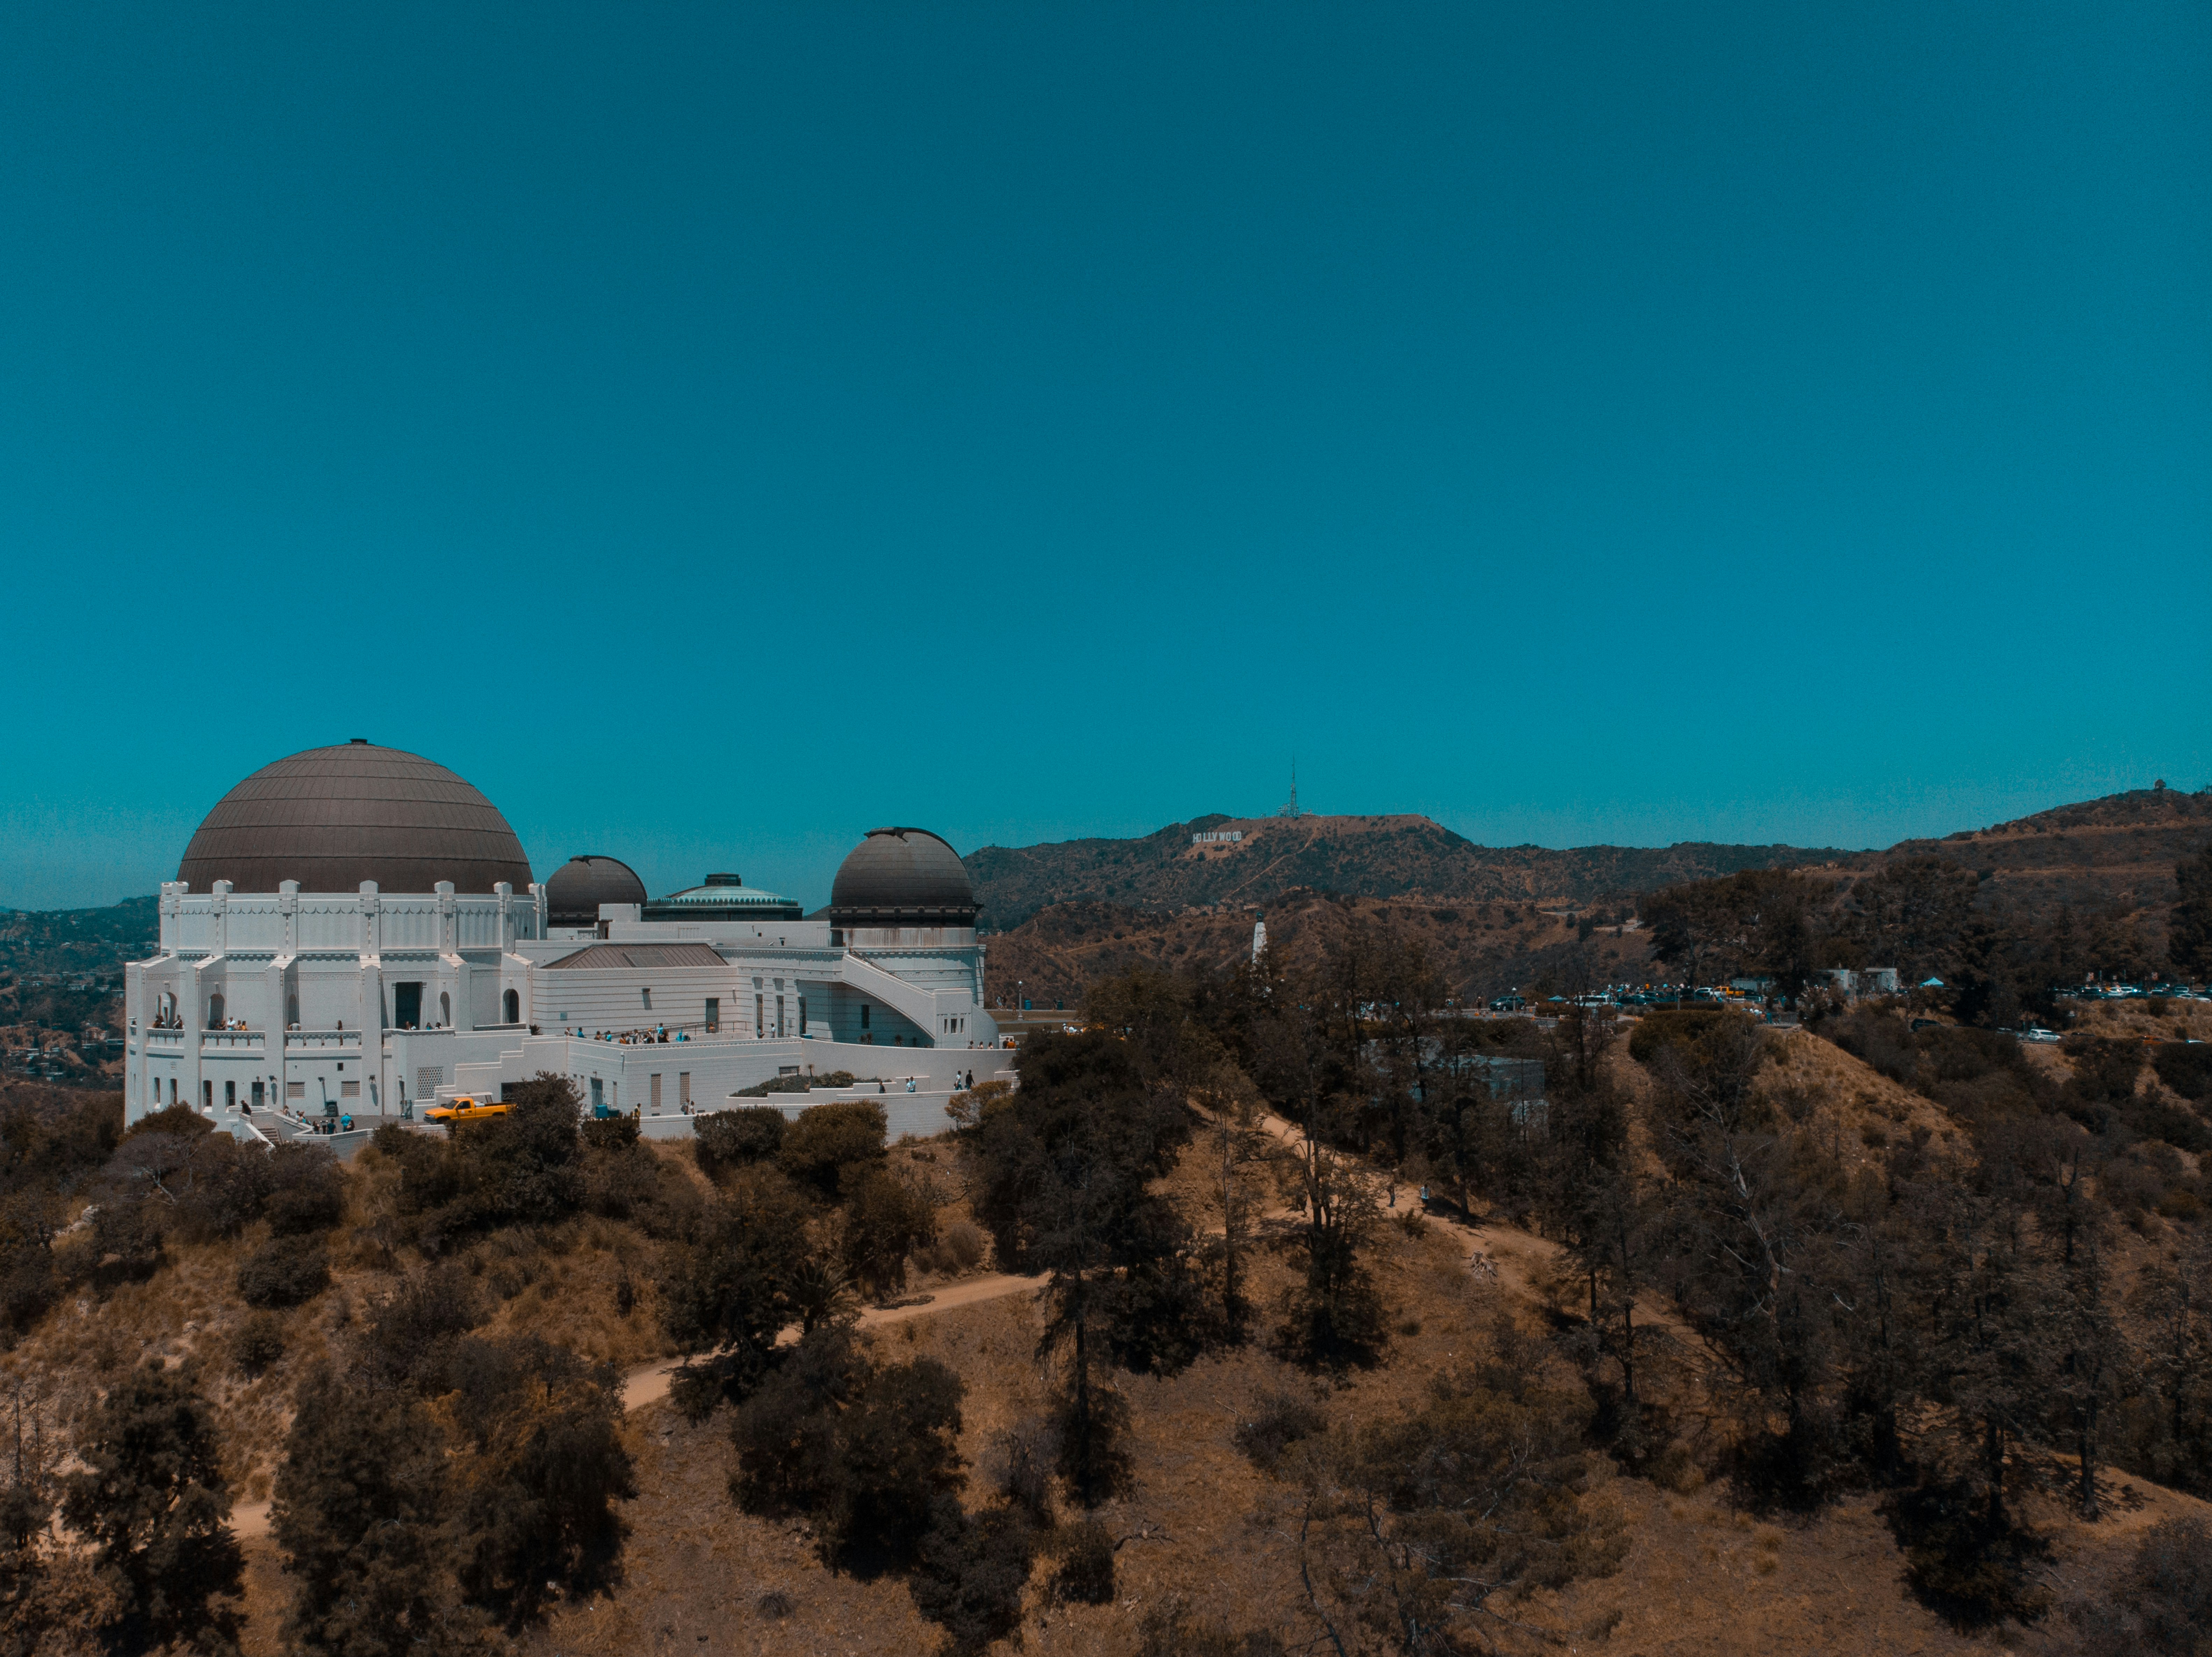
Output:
[962,814,1856,931]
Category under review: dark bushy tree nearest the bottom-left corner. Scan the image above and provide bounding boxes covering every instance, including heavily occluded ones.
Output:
[62,1363,245,1652]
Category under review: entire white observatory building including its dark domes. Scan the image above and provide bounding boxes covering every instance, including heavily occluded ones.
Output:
[124,739,1013,1135]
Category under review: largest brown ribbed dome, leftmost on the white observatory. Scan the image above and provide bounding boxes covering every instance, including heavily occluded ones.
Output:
[177,741,531,891]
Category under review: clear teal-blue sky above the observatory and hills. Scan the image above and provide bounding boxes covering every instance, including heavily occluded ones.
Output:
[0,0,2212,907]
